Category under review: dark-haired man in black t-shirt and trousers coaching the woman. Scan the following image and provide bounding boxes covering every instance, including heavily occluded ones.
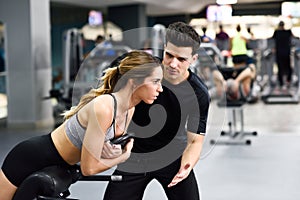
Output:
[104,22,210,200]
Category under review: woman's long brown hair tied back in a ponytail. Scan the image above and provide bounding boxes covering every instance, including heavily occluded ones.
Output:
[63,50,162,120]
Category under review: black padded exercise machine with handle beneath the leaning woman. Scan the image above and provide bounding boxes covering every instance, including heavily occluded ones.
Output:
[13,165,122,200]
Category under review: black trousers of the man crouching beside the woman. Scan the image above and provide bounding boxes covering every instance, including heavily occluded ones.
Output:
[104,159,200,200]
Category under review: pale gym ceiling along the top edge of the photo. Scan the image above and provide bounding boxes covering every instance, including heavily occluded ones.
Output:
[50,0,282,16]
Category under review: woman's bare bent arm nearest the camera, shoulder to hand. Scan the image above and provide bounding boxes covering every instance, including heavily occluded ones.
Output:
[80,97,133,175]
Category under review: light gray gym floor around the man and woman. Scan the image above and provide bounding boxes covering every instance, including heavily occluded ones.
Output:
[0,100,300,200]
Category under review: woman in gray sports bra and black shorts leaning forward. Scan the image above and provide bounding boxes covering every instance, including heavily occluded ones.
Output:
[0,51,163,200]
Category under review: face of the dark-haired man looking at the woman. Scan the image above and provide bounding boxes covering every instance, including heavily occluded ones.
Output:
[162,42,197,84]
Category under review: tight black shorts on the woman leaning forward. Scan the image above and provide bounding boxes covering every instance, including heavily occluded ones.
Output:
[2,134,70,187]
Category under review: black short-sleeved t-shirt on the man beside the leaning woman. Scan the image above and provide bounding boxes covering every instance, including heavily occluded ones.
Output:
[128,71,210,153]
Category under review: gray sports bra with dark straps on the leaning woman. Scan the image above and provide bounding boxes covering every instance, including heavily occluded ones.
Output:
[65,94,128,149]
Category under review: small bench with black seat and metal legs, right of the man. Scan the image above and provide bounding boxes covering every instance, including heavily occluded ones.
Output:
[210,97,257,145]
